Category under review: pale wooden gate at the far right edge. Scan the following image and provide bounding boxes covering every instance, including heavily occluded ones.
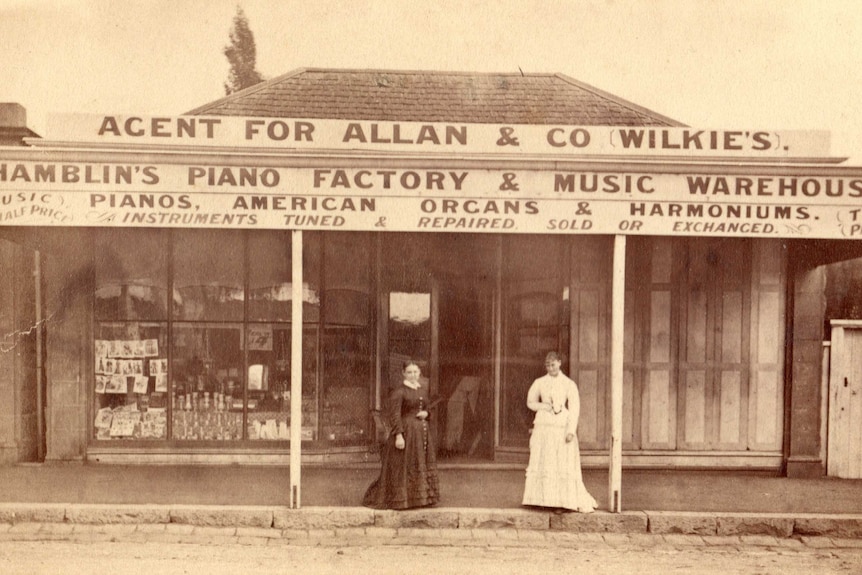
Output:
[826,320,862,478]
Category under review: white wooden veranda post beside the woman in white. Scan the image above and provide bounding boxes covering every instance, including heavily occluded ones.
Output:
[608,235,626,513]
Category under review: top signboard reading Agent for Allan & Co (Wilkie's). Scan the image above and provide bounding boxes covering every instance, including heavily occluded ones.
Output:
[42,114,829,161]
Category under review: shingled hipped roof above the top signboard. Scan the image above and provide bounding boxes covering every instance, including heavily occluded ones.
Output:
[188,69,682,126]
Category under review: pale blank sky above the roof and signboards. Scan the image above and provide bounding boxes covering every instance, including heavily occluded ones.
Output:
[5,0,862,162]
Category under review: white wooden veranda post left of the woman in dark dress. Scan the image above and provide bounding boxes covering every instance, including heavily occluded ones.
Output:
[290,230,303,509]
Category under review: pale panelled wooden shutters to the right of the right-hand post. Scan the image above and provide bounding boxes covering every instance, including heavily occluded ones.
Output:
[623,238,786,454]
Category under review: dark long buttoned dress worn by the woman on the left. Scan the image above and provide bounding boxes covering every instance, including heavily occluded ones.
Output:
[362,385,440,509]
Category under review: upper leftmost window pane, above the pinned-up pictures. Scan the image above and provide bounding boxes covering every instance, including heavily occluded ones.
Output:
[94,229,168,320]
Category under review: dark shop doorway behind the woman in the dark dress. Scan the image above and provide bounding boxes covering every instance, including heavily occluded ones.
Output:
[380,234,497,463]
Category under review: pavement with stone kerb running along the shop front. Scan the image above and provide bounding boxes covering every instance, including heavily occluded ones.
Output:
[0,463,862,548]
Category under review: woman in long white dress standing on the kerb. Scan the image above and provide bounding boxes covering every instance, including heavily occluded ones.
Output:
[523,351,597,513]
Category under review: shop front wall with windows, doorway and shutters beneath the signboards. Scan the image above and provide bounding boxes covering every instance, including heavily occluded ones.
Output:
[0,223,787,468]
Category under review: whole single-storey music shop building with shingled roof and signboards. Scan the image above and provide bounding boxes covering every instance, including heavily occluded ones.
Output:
[0,70,862,486]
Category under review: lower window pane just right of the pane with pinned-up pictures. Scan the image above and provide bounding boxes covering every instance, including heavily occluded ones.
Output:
[172,324,243,441]
